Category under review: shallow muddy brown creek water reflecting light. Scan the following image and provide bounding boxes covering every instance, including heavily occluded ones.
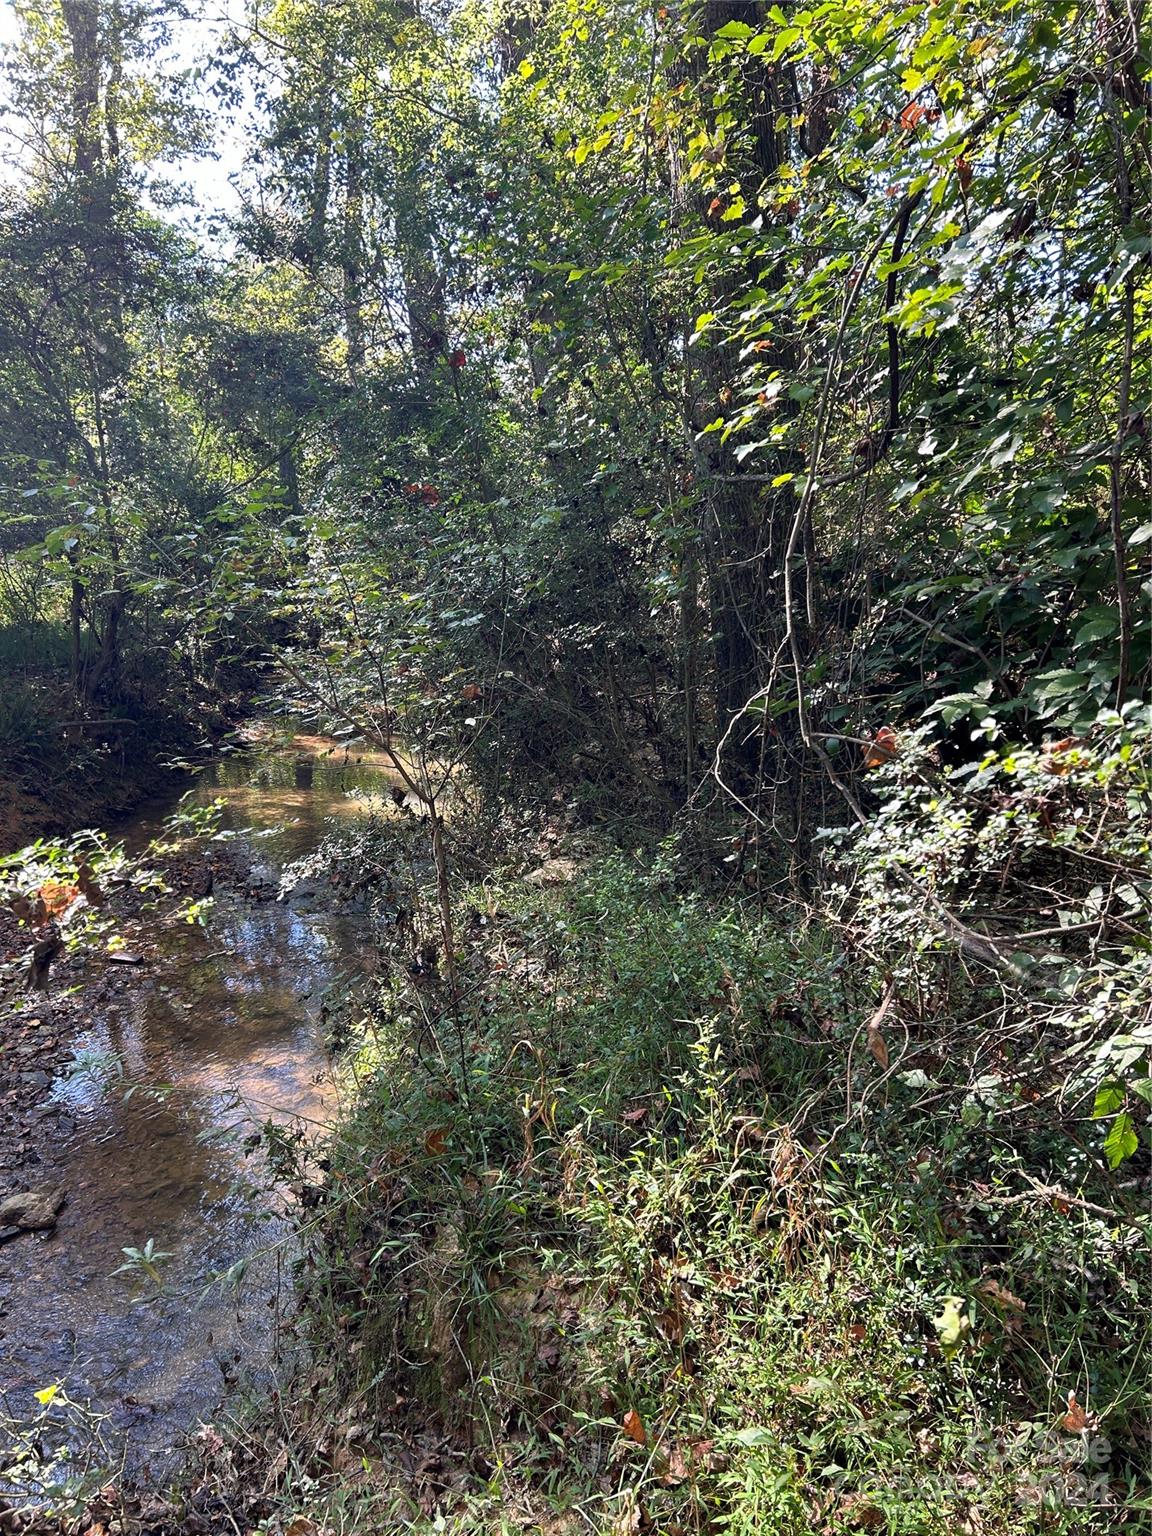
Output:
[0,724,405,1476]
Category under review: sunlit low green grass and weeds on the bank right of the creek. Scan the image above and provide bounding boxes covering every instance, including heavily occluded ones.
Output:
[239,828,1149,1536]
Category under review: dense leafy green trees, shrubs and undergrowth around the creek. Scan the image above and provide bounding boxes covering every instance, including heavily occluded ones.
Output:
[0,0,1152,1533]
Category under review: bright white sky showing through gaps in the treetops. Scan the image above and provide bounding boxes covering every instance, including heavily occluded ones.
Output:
[0,0,249,240]
